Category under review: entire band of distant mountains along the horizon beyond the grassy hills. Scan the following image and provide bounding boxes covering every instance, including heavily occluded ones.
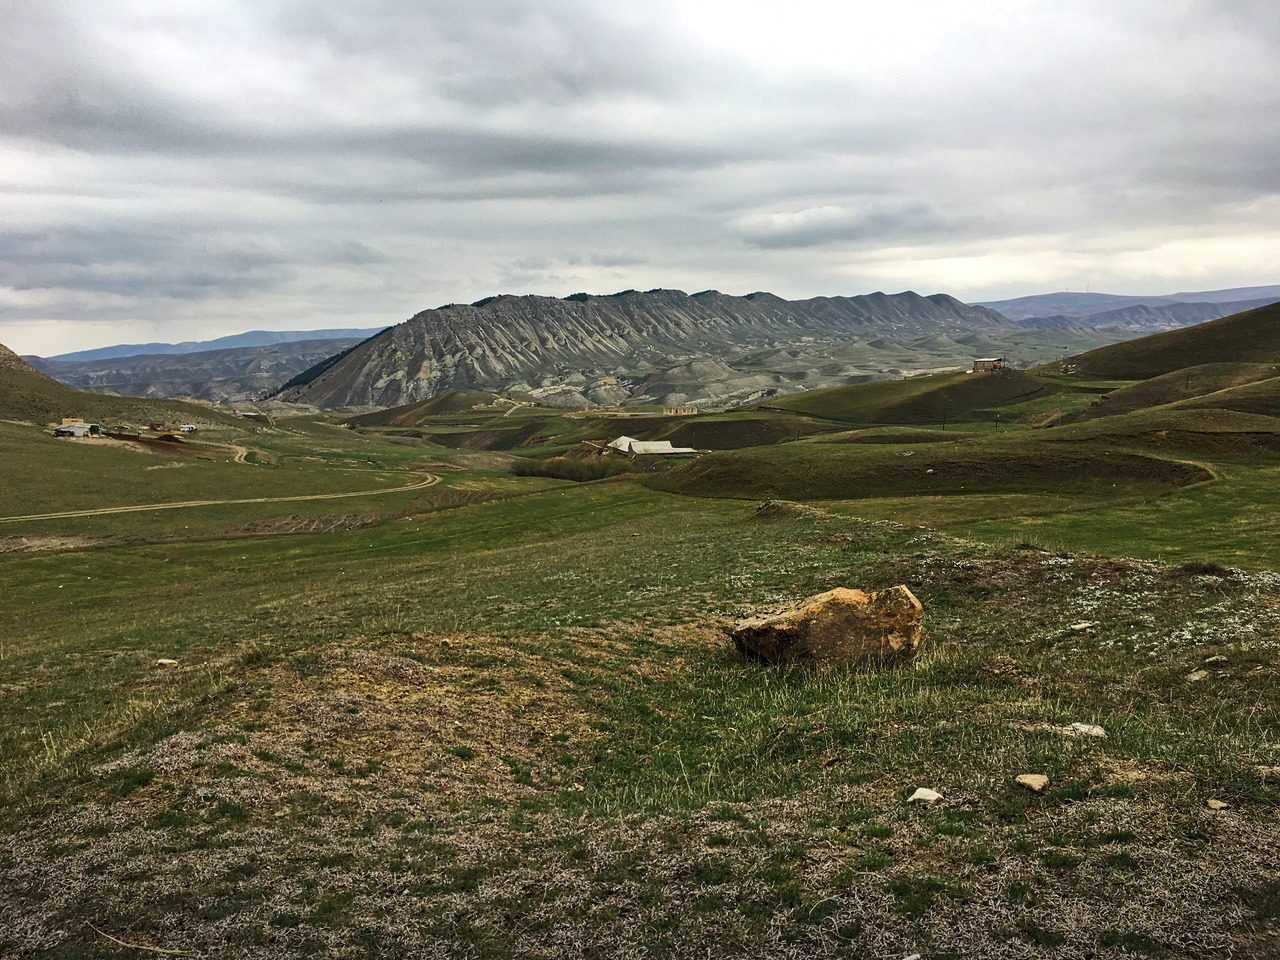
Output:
[27,284,1280,408]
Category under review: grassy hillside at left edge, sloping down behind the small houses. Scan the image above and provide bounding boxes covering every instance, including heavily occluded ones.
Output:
[0,344,240,429]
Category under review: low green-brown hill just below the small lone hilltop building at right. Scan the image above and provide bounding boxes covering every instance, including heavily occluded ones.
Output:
[767,370,1068,424]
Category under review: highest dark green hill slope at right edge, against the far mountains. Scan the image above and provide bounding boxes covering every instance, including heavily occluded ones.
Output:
[1037,303,1280,380]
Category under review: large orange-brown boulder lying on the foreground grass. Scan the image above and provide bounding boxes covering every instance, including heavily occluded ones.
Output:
[730,586,924,668]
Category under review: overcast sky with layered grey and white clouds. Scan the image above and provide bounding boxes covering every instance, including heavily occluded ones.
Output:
[0,0,1280,355]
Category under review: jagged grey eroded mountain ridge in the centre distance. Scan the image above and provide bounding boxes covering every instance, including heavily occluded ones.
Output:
[276,289,1009,408]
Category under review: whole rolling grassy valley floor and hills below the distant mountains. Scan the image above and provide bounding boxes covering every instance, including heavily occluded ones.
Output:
[0,299,1280,960]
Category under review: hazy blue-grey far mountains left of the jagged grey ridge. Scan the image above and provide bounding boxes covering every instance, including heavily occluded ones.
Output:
[28,338,360,403]
